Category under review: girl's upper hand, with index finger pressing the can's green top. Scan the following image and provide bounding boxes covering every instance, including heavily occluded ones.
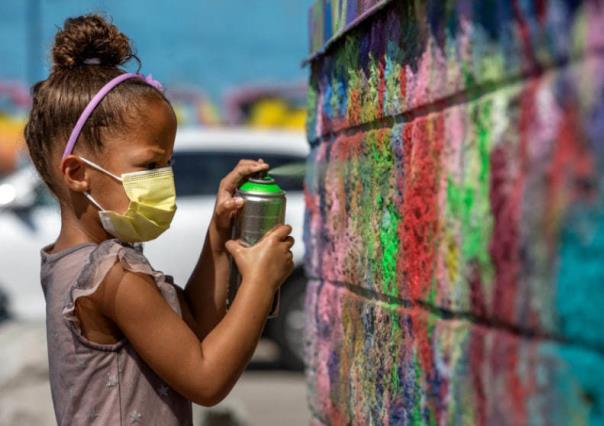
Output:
[213,158,269,235]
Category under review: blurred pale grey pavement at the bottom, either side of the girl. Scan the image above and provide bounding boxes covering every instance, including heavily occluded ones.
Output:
[0,321,310,426]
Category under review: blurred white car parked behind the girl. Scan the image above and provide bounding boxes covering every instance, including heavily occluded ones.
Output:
[0,128,309,368]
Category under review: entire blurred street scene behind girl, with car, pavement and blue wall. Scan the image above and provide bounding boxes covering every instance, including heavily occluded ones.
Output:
[0,0,311,426]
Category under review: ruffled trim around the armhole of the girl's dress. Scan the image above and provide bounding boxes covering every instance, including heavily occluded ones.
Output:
[62,239,182,350]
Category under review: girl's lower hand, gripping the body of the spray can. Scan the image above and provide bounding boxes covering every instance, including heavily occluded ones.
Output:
[225,225,294,291]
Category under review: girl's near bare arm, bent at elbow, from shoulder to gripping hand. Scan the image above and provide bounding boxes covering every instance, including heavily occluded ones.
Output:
[97,225,293,406]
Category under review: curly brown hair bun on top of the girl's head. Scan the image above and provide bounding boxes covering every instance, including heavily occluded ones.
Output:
[52,14,133,72]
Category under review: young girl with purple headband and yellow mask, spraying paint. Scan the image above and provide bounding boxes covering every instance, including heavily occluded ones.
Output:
[25,15,293,426]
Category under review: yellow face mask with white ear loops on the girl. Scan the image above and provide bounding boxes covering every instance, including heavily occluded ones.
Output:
[80,157,176,243]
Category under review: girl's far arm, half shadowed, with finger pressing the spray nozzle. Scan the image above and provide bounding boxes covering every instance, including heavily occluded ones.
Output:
[185,160,268,339]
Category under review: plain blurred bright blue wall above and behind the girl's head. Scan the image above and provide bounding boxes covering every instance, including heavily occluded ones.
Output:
[0,0,311,102]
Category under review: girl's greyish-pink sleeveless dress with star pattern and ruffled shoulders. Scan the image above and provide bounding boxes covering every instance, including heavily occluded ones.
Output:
[41,239,192,426]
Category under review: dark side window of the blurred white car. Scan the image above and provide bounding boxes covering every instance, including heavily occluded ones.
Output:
[174,151,305,197]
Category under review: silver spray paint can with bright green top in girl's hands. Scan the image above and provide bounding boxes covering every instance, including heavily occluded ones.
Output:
[227,172,285,318]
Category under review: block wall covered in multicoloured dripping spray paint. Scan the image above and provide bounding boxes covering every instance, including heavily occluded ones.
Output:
[305,0,604,425]
